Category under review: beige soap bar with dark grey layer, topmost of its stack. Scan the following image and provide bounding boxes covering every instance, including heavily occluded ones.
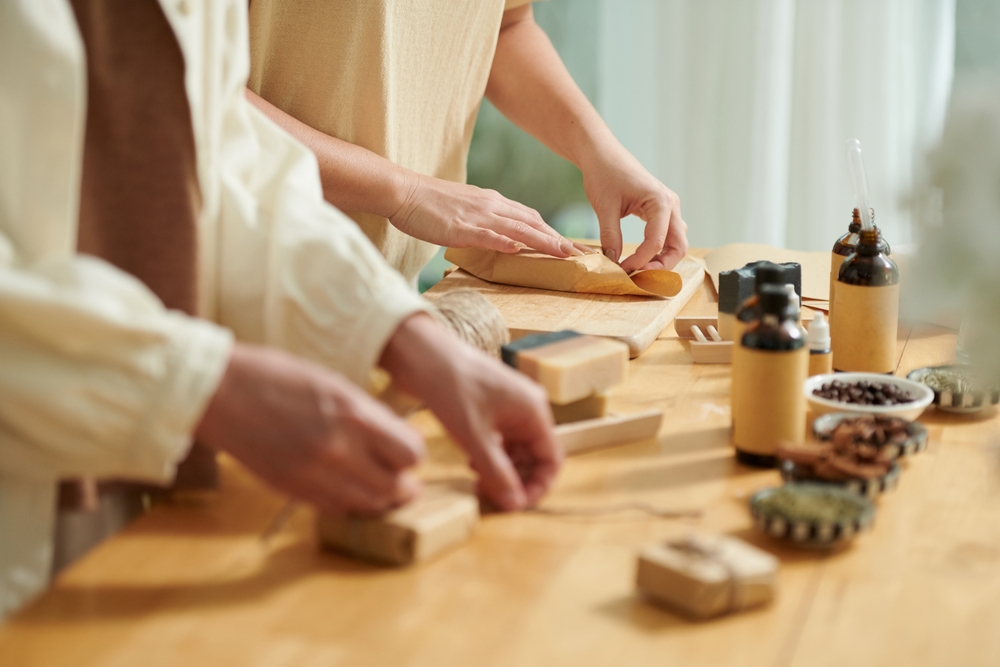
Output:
[502,331,628,405]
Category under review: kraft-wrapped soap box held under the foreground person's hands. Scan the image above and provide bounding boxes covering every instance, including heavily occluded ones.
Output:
[317,490,479,565]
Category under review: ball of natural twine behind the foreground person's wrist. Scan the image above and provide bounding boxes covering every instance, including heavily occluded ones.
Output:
[430,289,510,357]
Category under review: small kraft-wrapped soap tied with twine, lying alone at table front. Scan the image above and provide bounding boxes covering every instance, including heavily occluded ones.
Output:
[636,534,778,618]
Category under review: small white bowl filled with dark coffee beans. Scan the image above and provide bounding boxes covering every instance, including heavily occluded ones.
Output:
[803,373,934,421]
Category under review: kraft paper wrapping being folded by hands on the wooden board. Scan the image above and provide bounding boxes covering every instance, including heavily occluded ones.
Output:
[444,248,683,297]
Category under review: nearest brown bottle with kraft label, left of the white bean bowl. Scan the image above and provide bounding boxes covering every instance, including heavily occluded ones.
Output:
[733,285,809,467]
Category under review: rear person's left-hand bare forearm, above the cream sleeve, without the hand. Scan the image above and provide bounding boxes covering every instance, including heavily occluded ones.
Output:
[246,89,412,218]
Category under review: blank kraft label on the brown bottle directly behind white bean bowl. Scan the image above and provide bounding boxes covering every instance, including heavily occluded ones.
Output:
[830,283,899,373]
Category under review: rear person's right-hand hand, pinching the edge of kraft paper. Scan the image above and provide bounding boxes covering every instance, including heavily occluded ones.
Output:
[583,142,688,273]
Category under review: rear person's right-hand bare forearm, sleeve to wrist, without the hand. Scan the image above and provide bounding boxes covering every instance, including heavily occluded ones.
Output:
[486,5,620,169]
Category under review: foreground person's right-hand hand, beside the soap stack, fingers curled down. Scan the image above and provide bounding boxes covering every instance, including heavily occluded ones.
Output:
[381,315,563,510]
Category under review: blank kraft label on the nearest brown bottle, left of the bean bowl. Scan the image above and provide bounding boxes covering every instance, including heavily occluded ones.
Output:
[733,345,809,456]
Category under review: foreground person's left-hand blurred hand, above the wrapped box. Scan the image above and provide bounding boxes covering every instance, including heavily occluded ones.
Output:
[195,344,424,514]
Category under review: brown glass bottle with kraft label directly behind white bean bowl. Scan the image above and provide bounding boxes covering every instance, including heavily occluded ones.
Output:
[830,227,899,373]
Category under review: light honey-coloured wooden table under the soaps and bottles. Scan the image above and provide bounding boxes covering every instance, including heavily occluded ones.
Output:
[0,278,1000,667]
